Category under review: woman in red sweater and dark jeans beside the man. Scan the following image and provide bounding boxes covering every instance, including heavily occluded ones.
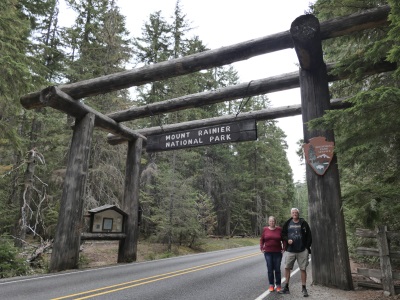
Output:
[260,216,284,292]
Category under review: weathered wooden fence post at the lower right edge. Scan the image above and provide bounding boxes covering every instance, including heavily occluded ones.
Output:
[376,226,396,296]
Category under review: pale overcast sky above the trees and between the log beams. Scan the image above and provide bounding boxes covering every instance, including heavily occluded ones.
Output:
[61,0,315,182]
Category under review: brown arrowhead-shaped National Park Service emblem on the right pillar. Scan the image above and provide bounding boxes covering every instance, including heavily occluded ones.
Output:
[303,136,334,175]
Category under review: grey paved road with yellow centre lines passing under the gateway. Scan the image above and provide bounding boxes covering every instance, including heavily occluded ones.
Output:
[0,246,304,300]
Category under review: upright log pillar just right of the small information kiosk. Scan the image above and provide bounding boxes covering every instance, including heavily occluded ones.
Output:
[118,138,143,263]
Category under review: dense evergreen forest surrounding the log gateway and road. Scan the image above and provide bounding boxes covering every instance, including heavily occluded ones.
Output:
[0,0,400,277]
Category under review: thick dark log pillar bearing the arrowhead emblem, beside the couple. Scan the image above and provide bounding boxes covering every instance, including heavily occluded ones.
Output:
[290,15,353,290]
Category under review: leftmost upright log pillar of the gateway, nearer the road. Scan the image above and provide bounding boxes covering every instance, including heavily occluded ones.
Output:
[50,113,95,272]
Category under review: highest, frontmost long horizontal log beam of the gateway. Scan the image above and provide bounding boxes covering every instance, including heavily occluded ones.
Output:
[20,6,390,109]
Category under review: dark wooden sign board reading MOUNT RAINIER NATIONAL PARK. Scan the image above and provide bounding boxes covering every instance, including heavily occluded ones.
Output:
[146,120,257,152]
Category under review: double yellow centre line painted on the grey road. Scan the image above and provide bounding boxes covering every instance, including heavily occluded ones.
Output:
[52,253,259,300]
